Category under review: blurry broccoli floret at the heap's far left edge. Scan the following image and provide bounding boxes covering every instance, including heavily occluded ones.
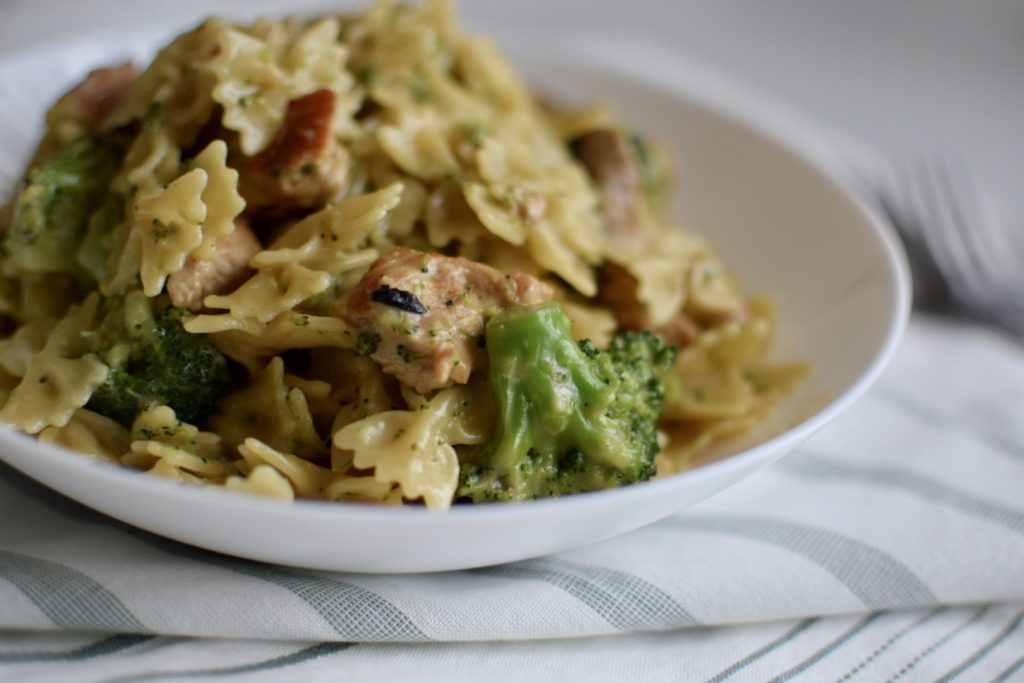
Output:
[5,136,121,272]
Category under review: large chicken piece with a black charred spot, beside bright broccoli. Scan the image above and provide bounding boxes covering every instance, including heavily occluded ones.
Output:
[332,248,554,393]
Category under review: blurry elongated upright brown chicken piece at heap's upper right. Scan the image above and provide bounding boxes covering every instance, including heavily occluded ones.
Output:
[575,130,645,249]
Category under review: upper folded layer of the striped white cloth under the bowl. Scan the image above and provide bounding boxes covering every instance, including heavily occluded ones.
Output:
[0,316,1024,643]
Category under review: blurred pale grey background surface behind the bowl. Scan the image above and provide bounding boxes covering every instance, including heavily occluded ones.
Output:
[0,0,1024,325]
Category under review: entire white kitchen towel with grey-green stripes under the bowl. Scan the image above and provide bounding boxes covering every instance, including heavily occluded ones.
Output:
[0,316,1024,681]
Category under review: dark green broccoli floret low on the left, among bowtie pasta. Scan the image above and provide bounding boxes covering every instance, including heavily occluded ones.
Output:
[86,292,230,427]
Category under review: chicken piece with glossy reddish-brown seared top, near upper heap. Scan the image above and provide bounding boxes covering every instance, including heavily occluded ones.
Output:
[232,90,349,208]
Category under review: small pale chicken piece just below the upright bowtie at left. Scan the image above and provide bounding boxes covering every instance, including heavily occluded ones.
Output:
[167,218,262,311]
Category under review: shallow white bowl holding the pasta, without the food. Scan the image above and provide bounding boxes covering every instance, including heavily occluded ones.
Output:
[0,29,909,572]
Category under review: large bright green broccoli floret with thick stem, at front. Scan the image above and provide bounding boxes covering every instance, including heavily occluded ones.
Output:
[459,303,675,502]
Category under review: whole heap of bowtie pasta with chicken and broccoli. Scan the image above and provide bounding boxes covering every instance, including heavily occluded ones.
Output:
[0,0,806,509]
